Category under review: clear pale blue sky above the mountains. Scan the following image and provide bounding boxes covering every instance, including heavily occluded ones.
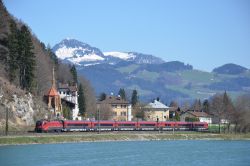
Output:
[4,0,250,71]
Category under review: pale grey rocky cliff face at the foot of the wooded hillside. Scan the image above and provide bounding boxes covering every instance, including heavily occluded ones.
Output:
[0,79,48,128]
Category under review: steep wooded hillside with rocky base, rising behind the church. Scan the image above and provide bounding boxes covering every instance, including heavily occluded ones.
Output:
[0,1,95,127]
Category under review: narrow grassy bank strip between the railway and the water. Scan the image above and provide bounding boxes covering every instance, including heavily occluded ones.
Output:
[0,132,250,145]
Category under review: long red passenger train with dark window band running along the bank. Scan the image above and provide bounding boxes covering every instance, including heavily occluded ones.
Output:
[35,120,208,132]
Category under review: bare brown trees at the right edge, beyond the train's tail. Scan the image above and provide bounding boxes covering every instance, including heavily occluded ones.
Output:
[170,92,250,132]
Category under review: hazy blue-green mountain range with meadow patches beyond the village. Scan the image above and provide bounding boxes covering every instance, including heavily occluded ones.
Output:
[51,38,250,103]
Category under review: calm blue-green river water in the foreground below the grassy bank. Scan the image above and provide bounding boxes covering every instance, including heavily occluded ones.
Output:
[0,140,250,166]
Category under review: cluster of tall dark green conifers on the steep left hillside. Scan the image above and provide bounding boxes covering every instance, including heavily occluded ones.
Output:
[5,20,36,91]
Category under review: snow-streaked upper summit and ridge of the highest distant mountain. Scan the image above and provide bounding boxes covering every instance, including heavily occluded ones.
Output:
[52,39,164,66]
